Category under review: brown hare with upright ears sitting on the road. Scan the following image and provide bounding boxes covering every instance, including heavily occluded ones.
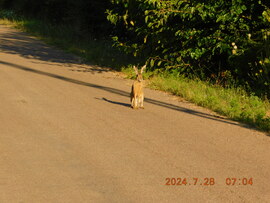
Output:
[130,65,146,109]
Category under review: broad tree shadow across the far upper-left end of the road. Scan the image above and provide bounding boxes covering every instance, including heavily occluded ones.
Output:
[0,29,110,73]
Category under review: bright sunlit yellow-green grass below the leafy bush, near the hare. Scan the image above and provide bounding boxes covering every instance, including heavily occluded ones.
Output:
[123,67,270,132]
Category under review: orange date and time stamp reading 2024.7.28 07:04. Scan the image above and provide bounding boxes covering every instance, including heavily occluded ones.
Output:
[165,177,253,186]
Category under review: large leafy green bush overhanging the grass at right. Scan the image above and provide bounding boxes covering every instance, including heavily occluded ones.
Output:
[107,0,270,96]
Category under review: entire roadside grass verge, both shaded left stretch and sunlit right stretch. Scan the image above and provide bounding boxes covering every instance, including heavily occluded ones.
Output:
[0,12,270,132]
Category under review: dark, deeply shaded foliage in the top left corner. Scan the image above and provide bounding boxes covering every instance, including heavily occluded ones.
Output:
[0,0,111,37]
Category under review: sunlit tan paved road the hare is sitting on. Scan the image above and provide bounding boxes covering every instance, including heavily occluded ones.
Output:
[0,26,270,202]
